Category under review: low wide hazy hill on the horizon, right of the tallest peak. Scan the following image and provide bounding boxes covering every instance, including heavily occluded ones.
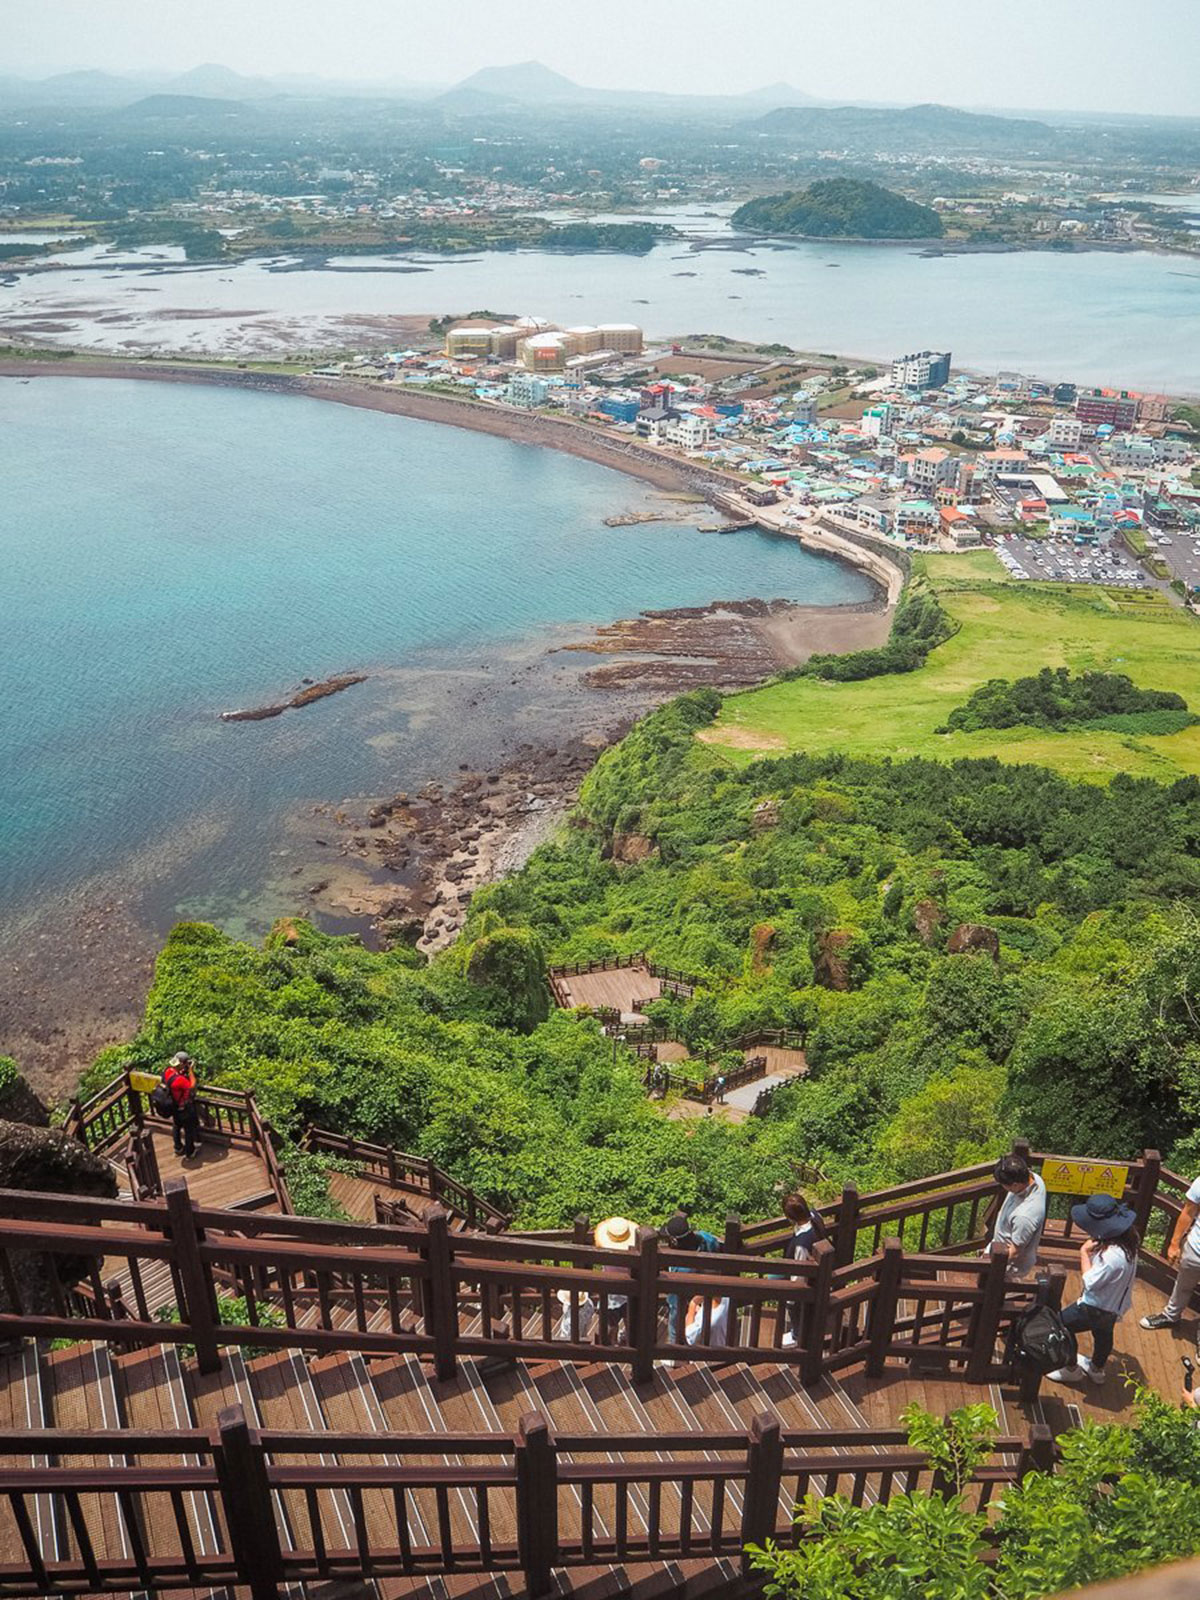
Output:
[749,104,1056,152]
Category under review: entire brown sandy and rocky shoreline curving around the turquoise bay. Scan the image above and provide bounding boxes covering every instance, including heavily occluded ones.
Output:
[0,357,902,1098]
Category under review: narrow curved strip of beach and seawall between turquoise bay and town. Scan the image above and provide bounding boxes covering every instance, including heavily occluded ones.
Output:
[0,355,907,605]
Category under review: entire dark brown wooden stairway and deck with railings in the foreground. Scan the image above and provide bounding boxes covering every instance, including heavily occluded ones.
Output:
[0,1085,1195,1600]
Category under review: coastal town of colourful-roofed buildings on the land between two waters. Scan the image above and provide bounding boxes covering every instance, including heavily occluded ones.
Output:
[314,317,1200,602]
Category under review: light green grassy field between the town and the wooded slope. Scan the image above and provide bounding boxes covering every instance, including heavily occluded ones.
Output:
[704,550,1200,781]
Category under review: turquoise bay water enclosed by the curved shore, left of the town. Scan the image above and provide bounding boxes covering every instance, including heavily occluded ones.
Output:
[0,376,870,925]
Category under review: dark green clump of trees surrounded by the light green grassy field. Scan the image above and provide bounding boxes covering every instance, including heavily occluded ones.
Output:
[939,667,1197,733]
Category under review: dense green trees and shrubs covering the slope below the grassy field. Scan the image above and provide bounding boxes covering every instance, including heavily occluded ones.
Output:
[96,691,1200,1224]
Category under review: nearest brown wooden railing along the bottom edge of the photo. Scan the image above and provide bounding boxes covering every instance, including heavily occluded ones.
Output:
[0,1405,1054,1600]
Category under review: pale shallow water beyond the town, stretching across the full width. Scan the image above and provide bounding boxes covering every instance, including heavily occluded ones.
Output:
[0,205,1200,394]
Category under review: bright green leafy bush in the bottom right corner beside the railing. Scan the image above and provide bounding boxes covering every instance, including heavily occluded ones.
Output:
[754,1390,1200,1600]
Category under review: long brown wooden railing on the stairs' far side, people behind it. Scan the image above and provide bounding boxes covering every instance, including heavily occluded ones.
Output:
[0,1179,1062,1384]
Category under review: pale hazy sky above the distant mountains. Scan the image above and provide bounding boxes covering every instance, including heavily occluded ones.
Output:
[9,0,1200,115]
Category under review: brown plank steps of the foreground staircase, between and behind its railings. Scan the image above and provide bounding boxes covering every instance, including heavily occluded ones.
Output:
[0,1342,1017,1600]
